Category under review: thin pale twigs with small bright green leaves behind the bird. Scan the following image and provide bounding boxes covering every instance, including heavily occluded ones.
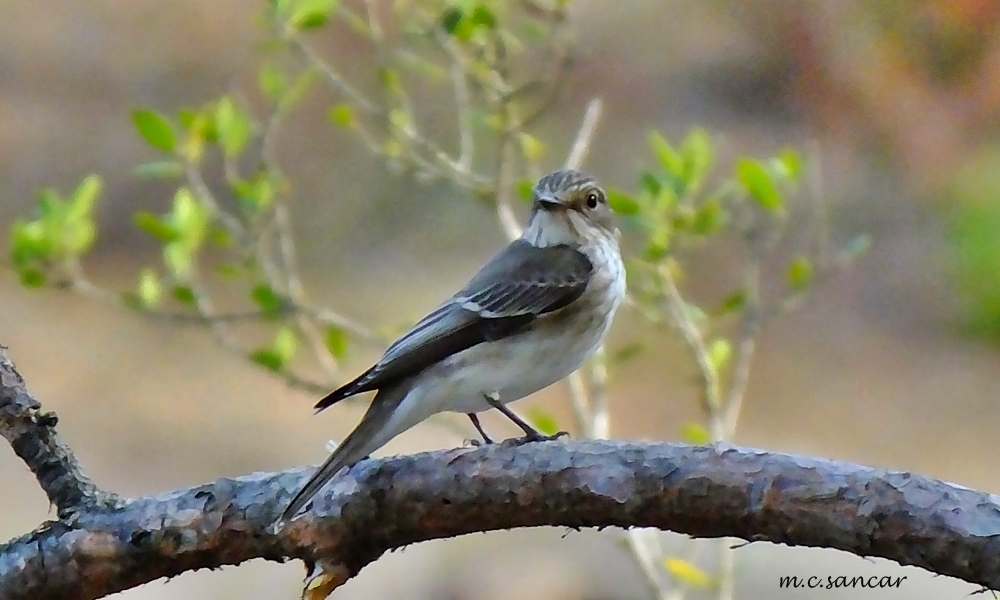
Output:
[3,0,867,600]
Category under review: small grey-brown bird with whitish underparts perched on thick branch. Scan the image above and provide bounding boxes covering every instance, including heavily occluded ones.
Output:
[278,169,626,526]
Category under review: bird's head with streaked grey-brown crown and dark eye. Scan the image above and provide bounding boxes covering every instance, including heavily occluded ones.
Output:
[522,169,618,246]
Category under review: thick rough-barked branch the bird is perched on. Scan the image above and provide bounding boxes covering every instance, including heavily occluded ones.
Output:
[0,346,1000,600]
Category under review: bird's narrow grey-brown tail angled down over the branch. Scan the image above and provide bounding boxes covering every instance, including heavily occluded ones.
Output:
[278,387,409,527]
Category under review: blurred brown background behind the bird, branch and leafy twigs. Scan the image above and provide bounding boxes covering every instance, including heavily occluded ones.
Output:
[0,0,1000,600]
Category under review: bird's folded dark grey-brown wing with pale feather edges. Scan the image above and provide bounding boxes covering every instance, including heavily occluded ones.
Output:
[316,240,594,410]
